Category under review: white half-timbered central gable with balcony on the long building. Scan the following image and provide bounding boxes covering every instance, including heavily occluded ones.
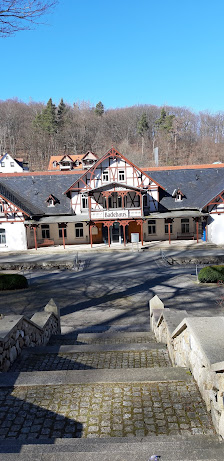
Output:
[71,153,159,214]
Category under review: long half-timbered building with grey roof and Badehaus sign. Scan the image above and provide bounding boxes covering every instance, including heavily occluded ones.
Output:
[0,148,224,250]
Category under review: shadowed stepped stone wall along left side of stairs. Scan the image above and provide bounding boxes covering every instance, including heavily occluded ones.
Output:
[0,299,60,371]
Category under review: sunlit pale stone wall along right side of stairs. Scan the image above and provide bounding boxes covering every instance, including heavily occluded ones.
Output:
[150,297,224,439]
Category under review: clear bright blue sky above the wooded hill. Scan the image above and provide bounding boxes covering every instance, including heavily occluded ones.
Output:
[0,0,224,112]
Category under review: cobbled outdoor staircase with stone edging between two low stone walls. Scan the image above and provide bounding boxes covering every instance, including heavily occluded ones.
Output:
[0,331,224,461]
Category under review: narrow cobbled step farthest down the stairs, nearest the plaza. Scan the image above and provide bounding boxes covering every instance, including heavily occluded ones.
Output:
[49,331,155,345]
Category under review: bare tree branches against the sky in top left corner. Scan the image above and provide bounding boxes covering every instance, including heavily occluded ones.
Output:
[0,0,57,37]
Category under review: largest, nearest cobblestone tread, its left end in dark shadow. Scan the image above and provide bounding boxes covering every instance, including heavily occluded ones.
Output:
[0,382,214,439]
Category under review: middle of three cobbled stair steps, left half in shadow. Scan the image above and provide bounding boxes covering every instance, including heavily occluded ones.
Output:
[10,343,171,372]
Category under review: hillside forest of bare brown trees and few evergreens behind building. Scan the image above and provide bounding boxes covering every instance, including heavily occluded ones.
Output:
[0,99,224,170]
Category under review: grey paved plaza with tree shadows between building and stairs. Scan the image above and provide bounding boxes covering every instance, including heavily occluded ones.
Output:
[0,251,224,333]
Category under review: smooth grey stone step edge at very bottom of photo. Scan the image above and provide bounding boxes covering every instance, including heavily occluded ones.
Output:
[0,436,224,461]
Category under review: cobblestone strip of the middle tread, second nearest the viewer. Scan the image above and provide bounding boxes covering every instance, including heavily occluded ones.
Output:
[11,350,171,372]
